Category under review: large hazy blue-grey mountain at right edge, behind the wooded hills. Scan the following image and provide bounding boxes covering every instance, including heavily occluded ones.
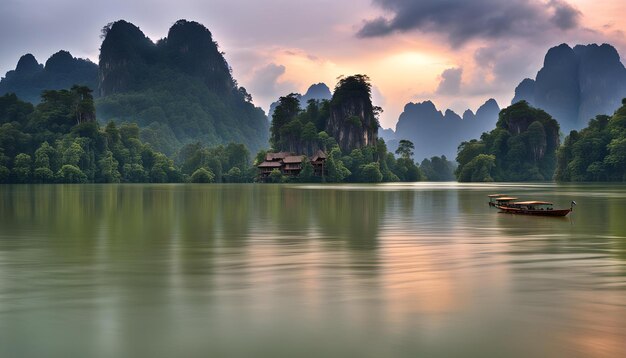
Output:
[512,44,626,134]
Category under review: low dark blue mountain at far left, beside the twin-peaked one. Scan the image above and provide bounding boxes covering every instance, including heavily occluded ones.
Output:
[0,50,98,104]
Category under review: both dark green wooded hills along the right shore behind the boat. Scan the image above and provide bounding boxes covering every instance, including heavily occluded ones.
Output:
[455,99,626,182]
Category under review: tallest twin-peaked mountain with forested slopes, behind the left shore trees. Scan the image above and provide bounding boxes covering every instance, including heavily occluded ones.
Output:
[96,20,269,154]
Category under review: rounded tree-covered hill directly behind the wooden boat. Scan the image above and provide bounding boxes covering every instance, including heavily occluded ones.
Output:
[455,101,559,182]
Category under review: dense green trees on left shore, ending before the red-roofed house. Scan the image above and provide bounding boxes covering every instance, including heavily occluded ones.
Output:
[0,86,252,183]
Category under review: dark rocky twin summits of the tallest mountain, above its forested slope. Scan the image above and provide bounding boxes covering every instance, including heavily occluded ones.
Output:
[100,20,236,96]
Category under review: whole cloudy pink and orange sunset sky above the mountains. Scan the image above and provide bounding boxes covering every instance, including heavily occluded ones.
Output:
[0,0,626,128]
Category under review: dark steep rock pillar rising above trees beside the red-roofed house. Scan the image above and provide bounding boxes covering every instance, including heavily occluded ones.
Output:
[326,76,379,153]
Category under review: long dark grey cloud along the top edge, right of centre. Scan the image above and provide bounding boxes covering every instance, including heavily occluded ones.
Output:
[357,0,581,46]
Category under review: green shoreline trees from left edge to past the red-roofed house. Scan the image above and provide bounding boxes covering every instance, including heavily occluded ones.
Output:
[0,86,452,183]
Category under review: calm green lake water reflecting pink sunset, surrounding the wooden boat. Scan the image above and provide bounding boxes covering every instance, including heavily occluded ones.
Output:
[0,183,626,357]
